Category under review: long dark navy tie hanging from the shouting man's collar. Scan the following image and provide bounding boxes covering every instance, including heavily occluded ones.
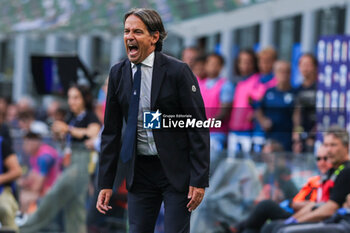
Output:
[120,63,141,163]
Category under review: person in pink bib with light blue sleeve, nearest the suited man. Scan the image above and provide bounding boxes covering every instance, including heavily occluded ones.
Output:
[201,53,234,166]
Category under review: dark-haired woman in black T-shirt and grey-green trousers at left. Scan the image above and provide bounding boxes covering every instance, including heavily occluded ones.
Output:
[20,85,100,233]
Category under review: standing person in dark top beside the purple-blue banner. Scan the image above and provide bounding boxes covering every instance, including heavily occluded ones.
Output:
[293,53,318,153]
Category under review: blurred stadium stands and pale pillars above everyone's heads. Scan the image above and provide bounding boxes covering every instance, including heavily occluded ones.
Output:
[0,0,350,100]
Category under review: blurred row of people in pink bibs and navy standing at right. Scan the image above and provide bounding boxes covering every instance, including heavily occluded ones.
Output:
[183,48,317,160]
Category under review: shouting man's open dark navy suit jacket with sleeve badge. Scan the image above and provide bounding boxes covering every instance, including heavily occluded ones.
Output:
[98,52,210,191]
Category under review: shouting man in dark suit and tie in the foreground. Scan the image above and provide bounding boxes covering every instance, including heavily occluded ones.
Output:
[96,9,209,233]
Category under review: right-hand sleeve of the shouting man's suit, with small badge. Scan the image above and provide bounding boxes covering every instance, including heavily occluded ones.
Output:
[178,64,210,188]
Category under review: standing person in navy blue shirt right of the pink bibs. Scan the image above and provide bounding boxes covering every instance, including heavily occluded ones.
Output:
[255,61,294,151]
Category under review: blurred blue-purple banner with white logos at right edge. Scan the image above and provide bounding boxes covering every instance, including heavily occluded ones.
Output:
[316,35,350,148]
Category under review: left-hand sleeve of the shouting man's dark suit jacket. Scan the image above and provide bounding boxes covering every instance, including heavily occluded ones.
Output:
[98,67,123,189]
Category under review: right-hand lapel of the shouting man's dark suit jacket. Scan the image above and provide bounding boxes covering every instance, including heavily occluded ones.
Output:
[151,52,165,110]
